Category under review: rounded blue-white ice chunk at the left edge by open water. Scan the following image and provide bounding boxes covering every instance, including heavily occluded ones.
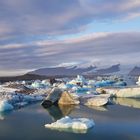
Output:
[0,100,14,112]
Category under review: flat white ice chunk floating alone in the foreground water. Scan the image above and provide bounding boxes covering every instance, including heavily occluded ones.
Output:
[45,116,95,133]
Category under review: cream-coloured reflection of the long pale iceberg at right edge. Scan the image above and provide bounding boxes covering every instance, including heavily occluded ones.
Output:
[113,98,140,108]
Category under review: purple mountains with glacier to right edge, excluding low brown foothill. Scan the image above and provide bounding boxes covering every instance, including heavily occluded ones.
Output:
[27,64,140,77]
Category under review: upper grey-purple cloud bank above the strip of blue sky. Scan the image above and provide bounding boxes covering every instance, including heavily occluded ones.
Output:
[0,0,140,37]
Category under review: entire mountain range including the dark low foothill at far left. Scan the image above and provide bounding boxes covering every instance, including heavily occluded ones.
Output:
[0,64,140,82]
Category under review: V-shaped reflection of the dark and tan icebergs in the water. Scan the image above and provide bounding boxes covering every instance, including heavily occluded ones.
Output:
[44,105,75,121]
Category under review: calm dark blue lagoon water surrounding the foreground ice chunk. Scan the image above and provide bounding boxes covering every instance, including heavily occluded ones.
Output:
[0,99,140,140]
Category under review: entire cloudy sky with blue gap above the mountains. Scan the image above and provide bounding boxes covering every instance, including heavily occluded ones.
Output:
[0,0,140,76]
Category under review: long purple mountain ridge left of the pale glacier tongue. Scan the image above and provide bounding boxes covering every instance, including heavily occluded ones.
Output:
[28,64,120,76]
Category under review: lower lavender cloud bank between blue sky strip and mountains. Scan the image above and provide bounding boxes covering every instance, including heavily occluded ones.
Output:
[0,32,140,75]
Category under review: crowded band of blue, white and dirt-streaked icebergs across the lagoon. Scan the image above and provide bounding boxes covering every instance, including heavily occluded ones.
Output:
[0,75,137,112]
